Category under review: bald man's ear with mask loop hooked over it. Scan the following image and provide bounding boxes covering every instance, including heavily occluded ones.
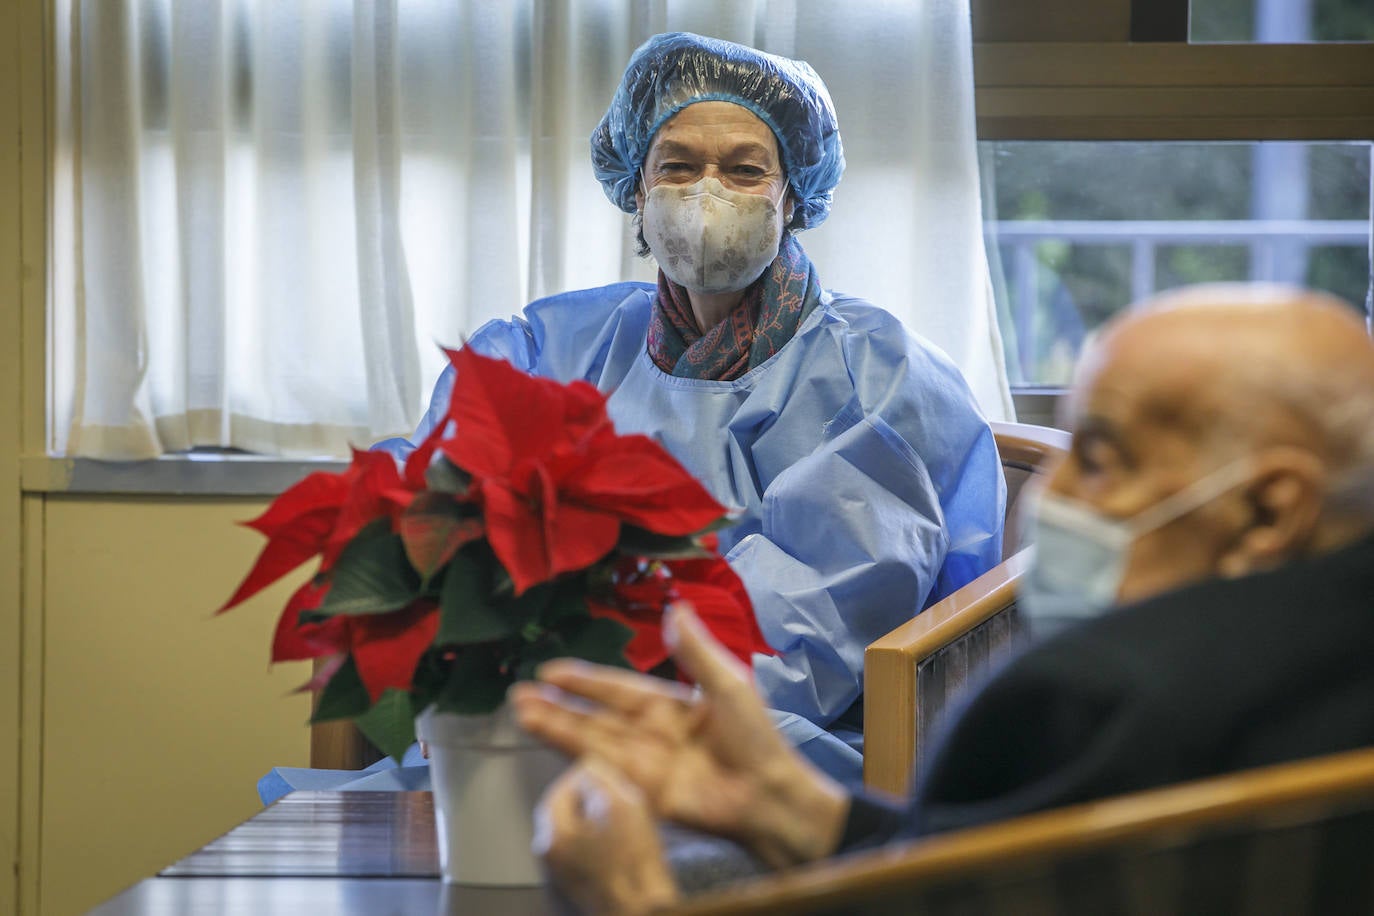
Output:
[1219,446,1327,577]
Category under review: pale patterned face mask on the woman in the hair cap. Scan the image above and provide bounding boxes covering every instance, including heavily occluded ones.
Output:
[644,179,782,293]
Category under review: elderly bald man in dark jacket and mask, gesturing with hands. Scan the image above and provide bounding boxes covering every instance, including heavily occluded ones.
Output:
[517,284,1374,912]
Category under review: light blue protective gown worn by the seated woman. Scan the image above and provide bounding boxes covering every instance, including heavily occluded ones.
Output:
[376,283,1006,781]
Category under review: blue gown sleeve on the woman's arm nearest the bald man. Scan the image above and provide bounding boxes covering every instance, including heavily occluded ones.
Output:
[728,307,1006,728]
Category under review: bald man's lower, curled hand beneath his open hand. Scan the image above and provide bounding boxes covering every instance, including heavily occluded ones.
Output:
[534,758,679,916]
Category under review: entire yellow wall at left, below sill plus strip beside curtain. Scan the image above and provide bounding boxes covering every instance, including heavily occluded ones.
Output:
[0,0,309,916]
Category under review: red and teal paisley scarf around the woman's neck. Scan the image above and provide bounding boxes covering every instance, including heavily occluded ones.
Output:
[649,236,820,382]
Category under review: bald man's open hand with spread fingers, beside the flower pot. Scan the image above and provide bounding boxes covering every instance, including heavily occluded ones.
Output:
[511,606,849,867]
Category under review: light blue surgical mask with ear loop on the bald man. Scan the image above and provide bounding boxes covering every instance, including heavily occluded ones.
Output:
[1017,457,1250,639]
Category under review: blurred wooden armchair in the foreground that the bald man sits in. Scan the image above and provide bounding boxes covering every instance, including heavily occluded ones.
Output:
[665,748,1374,916]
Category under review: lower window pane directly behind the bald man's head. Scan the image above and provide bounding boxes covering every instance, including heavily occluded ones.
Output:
[980,140,1371,387]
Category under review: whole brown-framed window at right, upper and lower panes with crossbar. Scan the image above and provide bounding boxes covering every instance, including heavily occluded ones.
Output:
[973,0,1374,406]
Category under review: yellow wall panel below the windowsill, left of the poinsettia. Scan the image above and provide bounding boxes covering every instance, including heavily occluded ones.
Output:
[34,496,309,916]
